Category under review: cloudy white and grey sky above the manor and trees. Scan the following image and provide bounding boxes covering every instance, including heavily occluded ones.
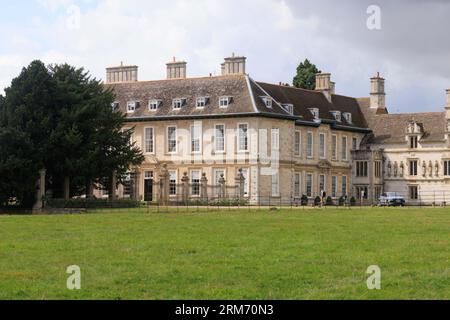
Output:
[0,0,450,113]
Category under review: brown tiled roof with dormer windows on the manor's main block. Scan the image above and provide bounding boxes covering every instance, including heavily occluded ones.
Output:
[106,75,368,131]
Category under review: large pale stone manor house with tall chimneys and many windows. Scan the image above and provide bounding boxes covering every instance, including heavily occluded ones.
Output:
[106,55,450,203]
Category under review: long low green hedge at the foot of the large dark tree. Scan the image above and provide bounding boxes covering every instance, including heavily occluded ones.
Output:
[45,199,141,209]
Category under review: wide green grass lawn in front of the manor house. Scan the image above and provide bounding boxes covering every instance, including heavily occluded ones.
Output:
[0,208,450,299]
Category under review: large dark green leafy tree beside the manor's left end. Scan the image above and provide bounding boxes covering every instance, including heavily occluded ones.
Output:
[0,61,143,205]
